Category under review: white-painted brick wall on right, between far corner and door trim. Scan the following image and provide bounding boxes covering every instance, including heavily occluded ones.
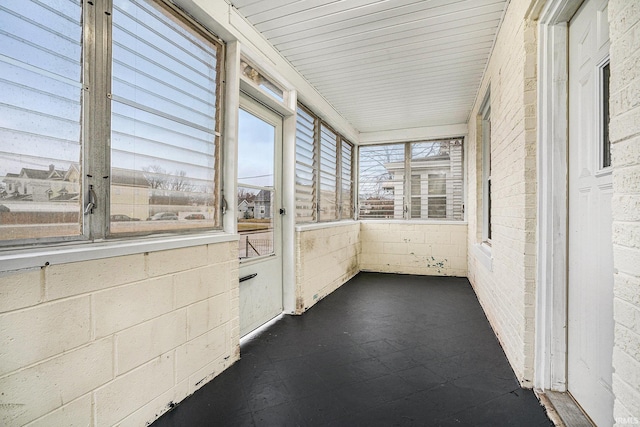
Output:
[467,1,537,387]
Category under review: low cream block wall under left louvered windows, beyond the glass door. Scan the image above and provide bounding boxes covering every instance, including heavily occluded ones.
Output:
[295,221,360,314]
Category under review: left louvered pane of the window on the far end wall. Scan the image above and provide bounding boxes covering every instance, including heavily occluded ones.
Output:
[358,144,405,219]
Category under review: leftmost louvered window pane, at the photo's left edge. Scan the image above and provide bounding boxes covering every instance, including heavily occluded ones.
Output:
[0,0,82,241]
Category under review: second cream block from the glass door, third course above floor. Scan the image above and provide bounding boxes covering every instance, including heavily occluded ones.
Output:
[116,309,187,375]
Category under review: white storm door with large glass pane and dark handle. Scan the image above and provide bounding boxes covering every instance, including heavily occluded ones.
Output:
[237,97,282,336]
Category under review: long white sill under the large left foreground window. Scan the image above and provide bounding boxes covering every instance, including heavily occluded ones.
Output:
[0,232,239,272]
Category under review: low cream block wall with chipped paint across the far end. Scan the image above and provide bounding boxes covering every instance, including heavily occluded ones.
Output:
[360,221,467,277]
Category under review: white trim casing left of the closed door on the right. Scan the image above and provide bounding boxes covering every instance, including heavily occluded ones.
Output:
[533,0,582,392]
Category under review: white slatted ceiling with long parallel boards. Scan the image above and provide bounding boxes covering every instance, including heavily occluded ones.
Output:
[230,0,507,132]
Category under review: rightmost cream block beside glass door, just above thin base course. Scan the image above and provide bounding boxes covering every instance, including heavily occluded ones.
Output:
[176,324,231,381]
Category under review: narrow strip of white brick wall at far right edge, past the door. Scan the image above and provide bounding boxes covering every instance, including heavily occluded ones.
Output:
[609,0,640,425]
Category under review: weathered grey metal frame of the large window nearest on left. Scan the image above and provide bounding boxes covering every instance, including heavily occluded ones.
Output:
[0,0,226,251]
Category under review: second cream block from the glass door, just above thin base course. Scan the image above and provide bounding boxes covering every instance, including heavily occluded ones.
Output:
[95,352,174,427]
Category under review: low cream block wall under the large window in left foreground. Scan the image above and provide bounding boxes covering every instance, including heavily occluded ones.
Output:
[0,241,239,426]
